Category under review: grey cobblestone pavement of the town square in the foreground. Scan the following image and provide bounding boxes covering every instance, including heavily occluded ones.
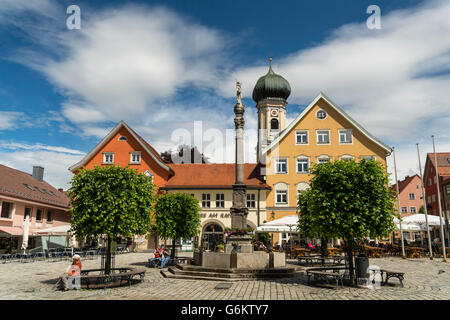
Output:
[0,253,450,300]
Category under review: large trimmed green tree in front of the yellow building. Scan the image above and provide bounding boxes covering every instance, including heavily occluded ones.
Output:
[298,160,399,282]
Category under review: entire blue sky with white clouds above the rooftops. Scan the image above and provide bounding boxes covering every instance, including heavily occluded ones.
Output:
[0,0,450,187]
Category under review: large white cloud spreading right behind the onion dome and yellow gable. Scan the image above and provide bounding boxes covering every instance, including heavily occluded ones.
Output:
[221,1,450,178]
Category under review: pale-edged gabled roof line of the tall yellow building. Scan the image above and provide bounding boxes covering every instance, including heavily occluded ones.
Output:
[262,92,392,154]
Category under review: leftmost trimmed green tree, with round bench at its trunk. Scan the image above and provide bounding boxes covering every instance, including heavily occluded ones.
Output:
[69,166,155,274]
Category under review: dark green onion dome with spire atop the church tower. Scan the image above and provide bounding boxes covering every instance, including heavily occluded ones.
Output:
[253,58,291,103]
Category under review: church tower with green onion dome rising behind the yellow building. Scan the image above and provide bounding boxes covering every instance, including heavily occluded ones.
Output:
[253,58,291,163]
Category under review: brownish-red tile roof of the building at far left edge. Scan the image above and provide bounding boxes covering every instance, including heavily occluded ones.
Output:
[0,164,69,209]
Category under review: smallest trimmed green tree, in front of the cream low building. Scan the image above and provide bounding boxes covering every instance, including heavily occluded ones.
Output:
[155,193,201,259]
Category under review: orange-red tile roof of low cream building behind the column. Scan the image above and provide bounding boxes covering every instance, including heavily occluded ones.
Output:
[161,163,270,189]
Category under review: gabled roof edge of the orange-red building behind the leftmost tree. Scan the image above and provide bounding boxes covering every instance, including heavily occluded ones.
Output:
[69,120,173,174]
